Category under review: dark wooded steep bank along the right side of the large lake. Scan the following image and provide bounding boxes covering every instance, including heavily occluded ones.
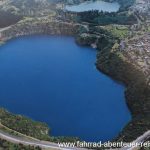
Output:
[96,37,150,141]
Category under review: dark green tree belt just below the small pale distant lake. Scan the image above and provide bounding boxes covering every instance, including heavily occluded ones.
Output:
[76,10,137,25]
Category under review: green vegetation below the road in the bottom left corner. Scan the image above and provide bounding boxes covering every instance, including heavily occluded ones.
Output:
[0,139,41,150]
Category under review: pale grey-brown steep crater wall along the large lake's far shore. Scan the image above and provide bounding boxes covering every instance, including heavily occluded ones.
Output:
[1,18,84,41]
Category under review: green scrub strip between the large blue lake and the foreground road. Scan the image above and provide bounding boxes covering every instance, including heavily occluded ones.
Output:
[0,108,79,143]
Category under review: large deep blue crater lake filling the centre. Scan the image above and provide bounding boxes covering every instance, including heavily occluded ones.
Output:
[0,36,130,141]
